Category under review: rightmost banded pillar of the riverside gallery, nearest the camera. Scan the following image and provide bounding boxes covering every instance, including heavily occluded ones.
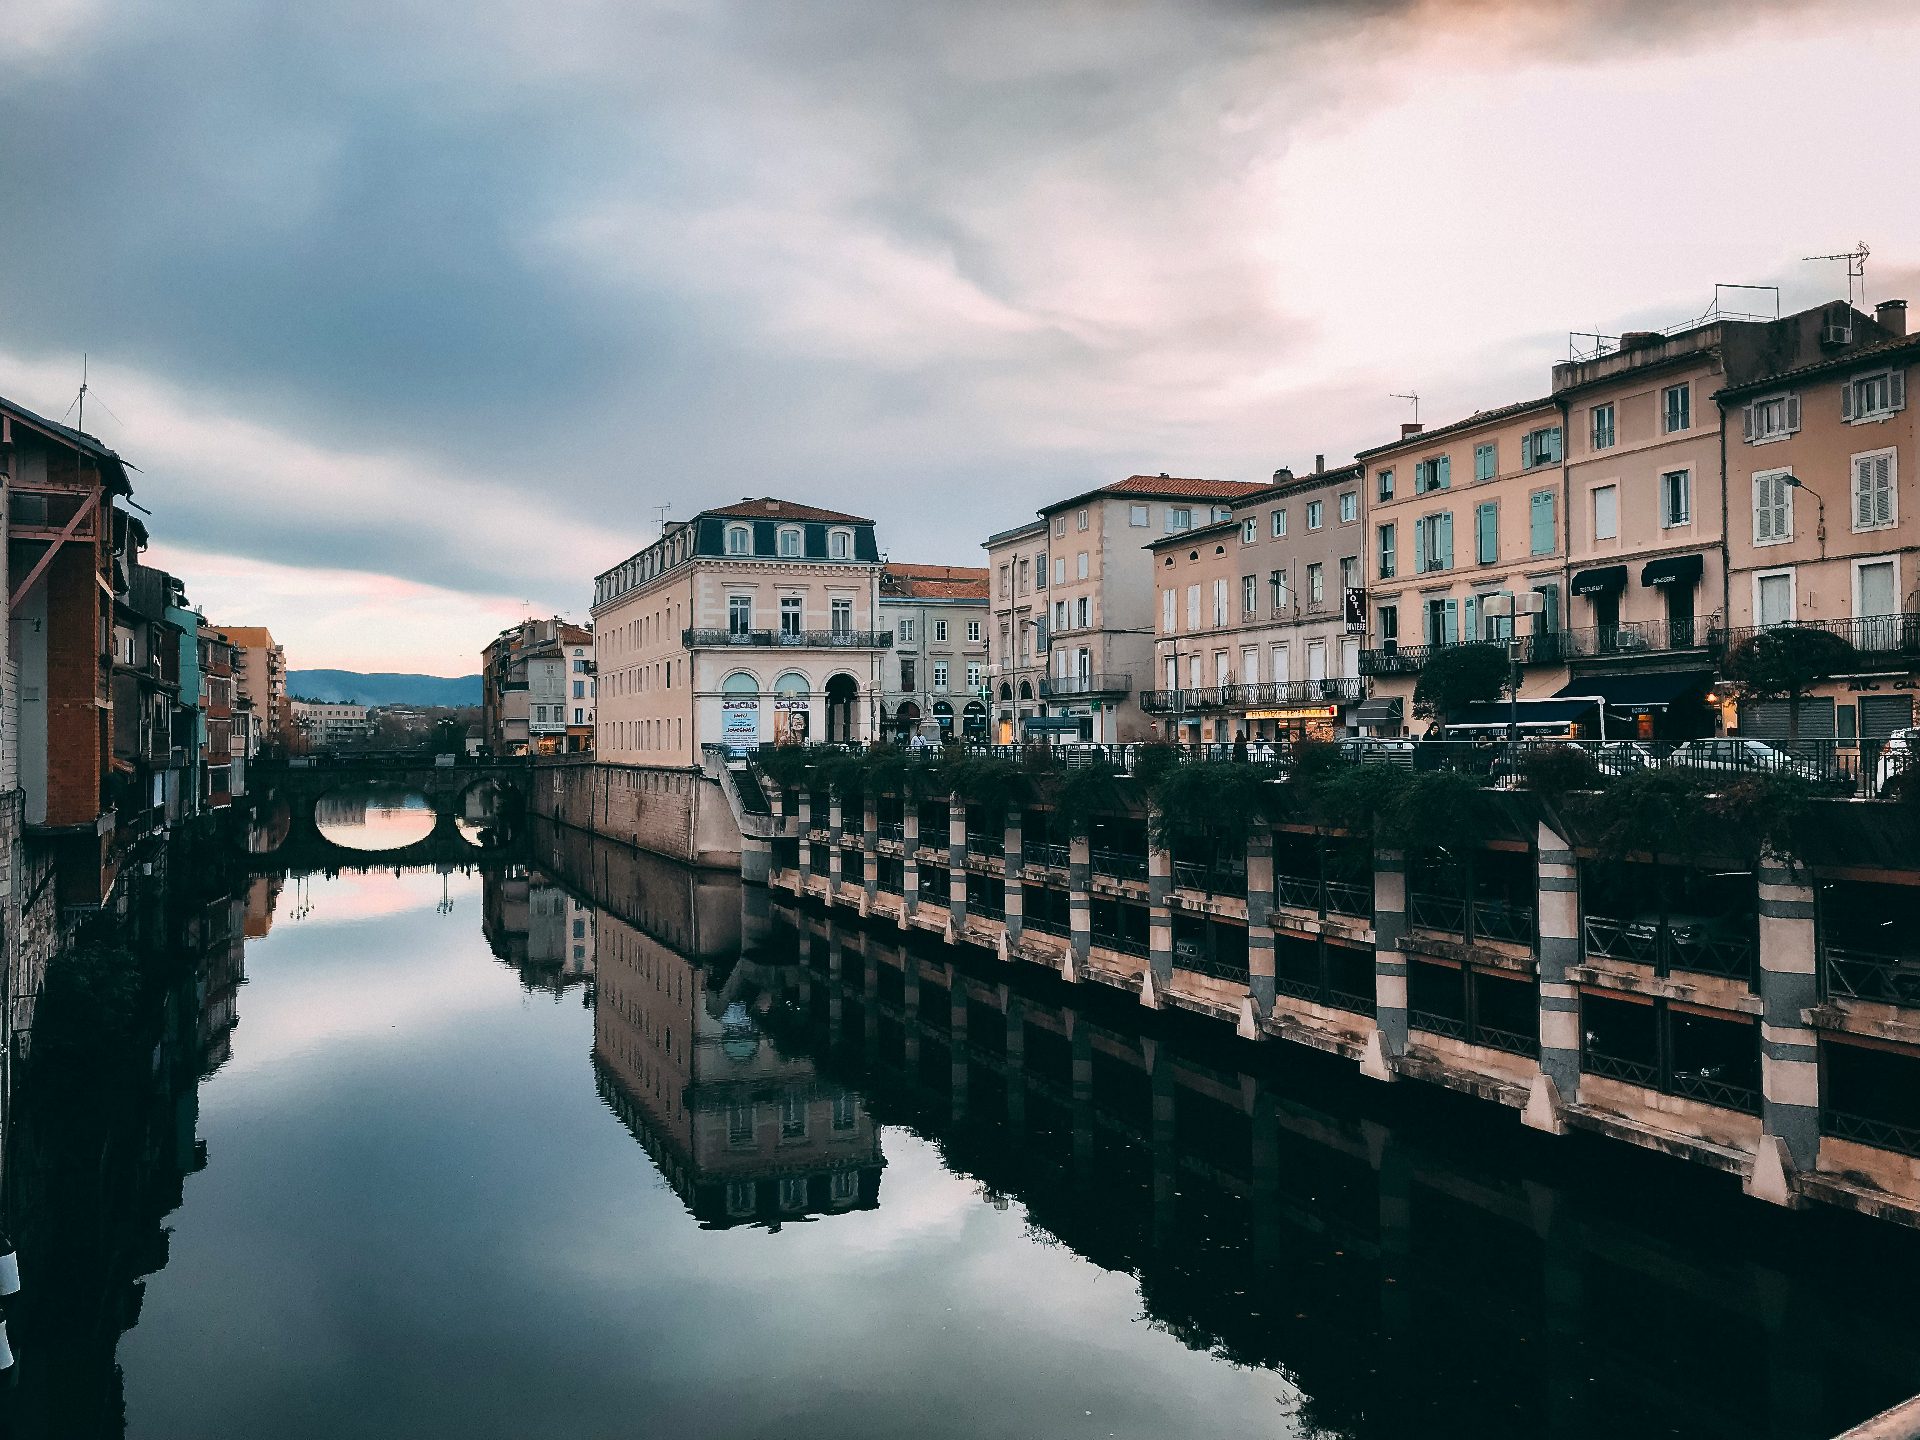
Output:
[1747,851,1820,1204]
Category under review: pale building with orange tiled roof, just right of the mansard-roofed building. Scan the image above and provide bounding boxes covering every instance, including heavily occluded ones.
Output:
[879,564,991,741]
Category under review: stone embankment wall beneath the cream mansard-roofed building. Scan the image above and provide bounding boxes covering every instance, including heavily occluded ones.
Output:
[530,760,741,872]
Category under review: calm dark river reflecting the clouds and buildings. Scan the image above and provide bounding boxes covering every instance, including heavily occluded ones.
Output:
[6,806,1920,1440]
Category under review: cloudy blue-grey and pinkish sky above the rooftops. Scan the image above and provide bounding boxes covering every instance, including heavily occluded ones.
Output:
[0,0,1920,674]
